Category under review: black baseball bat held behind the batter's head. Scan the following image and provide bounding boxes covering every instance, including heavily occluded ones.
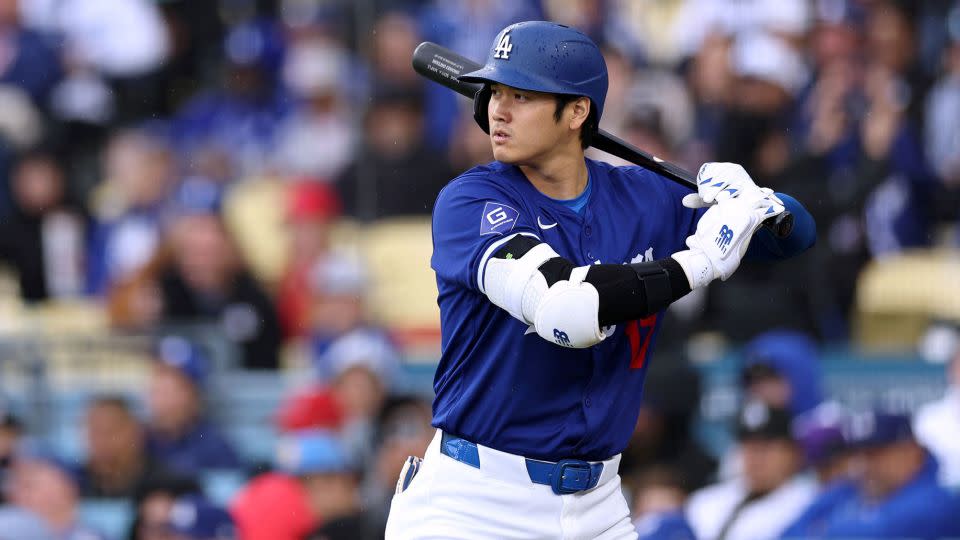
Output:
[413,41,793,232]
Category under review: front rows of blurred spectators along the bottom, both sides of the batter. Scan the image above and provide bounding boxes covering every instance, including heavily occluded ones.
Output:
[0,330,960,540]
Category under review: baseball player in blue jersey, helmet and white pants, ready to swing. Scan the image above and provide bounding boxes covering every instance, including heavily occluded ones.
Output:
[386,21,816,539]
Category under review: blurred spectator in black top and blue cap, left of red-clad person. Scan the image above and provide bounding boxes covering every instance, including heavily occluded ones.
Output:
[160,188,281,369]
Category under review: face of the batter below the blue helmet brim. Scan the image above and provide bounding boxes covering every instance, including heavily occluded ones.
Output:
[487,84,566,165]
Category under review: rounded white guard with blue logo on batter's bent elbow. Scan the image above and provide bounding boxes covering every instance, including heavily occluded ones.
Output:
[533,266,607,349]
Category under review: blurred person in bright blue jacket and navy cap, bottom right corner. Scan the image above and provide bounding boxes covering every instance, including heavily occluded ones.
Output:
[782,412,960,539]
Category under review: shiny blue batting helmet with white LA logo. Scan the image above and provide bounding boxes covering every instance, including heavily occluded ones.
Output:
[459,21,607,132]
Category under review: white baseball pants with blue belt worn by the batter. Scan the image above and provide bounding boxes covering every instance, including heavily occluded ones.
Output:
[386,430,637,540]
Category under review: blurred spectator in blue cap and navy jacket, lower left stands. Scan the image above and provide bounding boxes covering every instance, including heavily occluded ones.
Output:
[147,336,240,474]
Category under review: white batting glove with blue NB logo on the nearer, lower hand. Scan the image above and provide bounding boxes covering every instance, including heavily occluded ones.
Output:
[672,192,784,289]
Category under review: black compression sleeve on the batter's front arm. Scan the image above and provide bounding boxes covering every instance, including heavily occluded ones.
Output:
[493,236,690,326]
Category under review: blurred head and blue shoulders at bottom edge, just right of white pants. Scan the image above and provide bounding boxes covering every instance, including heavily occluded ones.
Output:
[630,466,696,540]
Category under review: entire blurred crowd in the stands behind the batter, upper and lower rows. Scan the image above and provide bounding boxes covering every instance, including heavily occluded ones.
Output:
[0,0,960,540]
